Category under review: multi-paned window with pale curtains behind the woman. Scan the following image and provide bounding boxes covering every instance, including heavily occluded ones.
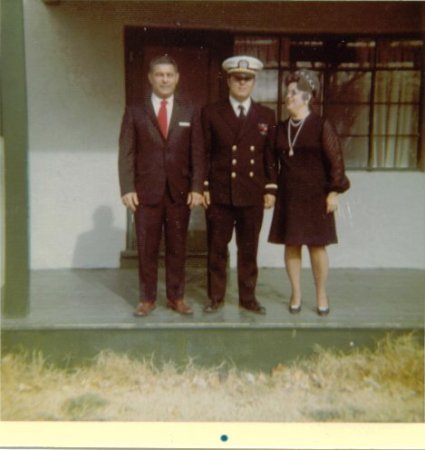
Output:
[234,36,424,169]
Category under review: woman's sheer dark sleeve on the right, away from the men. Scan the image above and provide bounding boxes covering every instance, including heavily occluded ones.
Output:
[322,120,350,193]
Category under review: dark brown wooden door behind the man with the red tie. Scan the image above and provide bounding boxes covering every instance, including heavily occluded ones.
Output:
[123,27,233,264]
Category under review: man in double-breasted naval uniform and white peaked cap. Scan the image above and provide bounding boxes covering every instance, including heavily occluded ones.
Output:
[202,56,277,314]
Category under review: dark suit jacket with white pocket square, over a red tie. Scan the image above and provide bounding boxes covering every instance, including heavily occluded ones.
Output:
[118,97,205,205]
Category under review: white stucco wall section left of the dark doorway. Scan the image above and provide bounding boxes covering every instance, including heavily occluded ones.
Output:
[24,0,126,269]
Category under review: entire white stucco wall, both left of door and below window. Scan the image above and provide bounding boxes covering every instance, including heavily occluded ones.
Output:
[24,0,425,269]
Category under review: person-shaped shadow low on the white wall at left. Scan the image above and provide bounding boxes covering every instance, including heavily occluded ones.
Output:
[73,206,125,268]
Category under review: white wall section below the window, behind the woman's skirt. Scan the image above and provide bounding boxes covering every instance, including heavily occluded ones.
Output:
[250,171,425,268]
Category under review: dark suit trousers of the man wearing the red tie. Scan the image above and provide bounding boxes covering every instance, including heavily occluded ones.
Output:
[134,189,190,302]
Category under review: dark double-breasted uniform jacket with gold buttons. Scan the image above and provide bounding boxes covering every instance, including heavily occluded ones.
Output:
[202,99,277,206]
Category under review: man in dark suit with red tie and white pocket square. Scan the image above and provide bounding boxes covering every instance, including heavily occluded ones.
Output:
[119,56,205,316]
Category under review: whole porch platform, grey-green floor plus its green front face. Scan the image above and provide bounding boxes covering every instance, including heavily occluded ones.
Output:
[1,268,425,369]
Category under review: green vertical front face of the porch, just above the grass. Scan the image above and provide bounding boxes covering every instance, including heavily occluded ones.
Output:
[1,326,424,372]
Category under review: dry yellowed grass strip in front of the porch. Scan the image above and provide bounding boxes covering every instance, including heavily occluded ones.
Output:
[1,335,424,422]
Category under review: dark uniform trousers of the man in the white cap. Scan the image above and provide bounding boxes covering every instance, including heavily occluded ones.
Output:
[207,204,264,304]
